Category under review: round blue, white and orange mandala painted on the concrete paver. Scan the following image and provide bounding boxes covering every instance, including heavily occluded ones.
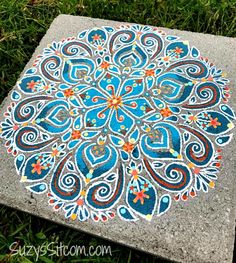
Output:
[0,25,235,221]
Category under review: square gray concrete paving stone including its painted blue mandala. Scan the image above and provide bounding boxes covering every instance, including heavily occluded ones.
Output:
[0,15,236,262]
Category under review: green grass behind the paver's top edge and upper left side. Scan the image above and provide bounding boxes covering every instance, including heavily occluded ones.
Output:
[0,0,236,101]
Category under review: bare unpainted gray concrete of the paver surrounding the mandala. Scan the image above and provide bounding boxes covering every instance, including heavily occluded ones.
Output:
[0,15,236,263]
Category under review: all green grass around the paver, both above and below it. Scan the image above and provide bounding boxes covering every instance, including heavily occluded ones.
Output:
[0,0,236,262]
